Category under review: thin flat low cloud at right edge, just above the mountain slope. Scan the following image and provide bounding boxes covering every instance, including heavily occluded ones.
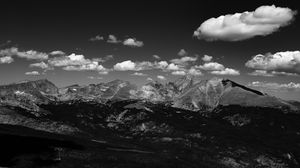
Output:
[248,81,300,91]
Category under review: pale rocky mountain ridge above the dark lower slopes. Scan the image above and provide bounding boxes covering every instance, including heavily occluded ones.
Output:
[0,75,299,111]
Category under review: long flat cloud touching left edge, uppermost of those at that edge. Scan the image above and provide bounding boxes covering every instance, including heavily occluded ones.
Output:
[0,47,48,60]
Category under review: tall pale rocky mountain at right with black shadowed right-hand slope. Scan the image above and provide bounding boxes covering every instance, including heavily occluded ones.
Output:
[174,78,294,110]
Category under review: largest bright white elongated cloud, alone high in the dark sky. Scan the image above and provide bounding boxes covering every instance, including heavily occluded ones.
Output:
[194,5,296,41]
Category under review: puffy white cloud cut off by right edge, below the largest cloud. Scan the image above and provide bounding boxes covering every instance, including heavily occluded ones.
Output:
[245,51,300,74]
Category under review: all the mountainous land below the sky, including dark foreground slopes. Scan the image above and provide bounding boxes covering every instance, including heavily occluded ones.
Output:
[0,76,300,168]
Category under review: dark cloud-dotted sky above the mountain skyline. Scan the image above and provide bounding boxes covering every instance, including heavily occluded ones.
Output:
[0,0,300,101]
